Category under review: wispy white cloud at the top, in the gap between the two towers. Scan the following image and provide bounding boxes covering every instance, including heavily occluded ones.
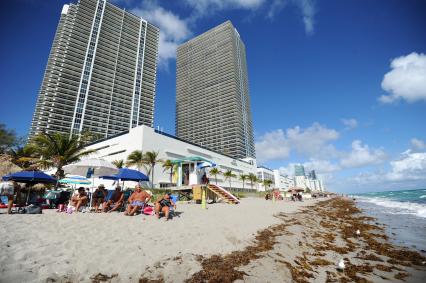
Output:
[132,1,192,68]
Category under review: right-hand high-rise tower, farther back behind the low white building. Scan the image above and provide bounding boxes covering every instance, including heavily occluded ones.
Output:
[176,21,255,159]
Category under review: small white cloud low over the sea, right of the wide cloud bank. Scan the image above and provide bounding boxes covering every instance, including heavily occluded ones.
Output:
[340,140,387,168]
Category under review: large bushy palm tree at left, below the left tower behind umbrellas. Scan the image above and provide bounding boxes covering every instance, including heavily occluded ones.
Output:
[28,133,96,178]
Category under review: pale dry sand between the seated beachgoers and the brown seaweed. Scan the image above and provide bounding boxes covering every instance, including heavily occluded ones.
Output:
[0,198,315,282]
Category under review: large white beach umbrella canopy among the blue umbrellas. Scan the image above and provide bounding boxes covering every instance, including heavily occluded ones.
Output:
[63,159,118,178]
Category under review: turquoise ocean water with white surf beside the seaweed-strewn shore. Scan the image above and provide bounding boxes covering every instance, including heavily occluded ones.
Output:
[351,189,426,254]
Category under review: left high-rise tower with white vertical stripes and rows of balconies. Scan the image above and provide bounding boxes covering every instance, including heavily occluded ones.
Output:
[30,0,159,138]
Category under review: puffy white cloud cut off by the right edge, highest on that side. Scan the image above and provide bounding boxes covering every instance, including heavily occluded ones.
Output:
[379,52,426,103]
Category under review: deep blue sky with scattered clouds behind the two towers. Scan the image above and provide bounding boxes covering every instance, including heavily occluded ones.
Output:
[0,0,426,192]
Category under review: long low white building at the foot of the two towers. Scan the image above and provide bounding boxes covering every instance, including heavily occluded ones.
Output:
[82,125,256,189]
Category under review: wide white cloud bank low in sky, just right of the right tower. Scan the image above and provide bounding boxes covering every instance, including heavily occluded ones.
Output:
[256,123,339,162]
